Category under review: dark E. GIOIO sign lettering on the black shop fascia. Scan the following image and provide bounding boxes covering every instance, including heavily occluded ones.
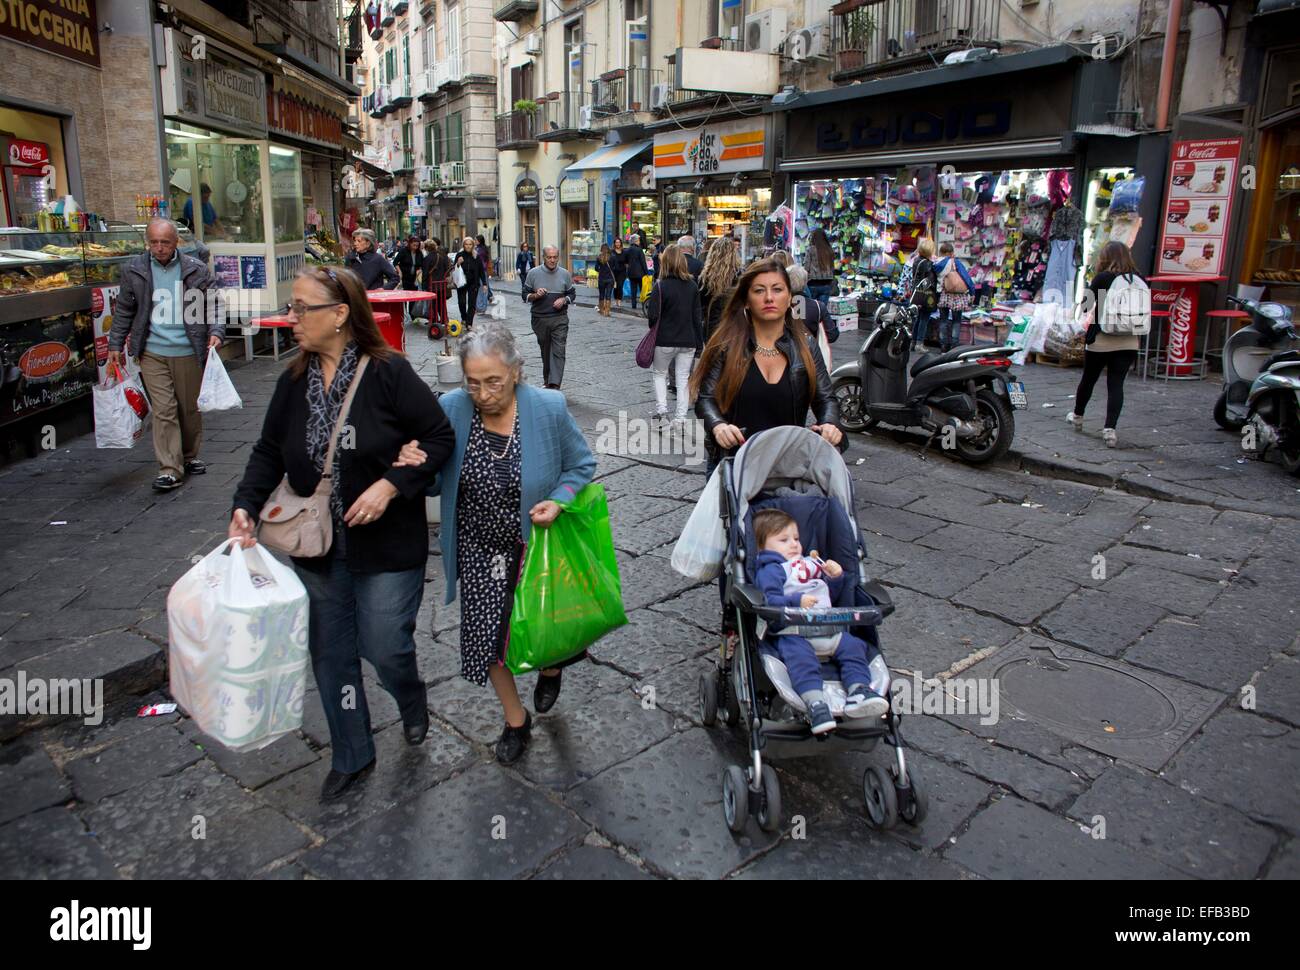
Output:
[816,100,1011,152]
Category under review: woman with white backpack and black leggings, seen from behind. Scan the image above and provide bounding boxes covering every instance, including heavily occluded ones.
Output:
[1066,242,1151,447]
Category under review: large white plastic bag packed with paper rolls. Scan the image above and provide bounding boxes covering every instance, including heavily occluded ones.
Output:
[166,540,309,752]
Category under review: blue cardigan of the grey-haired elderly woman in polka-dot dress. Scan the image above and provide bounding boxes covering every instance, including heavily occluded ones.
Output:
[429,384,595,603]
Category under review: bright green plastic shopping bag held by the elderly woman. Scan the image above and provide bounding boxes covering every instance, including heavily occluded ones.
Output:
[506,482,628,674]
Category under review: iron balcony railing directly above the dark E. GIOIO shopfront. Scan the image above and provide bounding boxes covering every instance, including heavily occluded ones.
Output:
[831,0,1001,77]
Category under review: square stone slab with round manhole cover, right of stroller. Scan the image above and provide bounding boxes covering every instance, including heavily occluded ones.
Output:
[963,640,1222,771]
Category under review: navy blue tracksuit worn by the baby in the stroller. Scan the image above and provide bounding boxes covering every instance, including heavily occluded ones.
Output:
[754,550,871,697]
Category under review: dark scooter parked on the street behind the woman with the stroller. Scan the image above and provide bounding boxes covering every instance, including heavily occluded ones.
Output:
[831,287,1028,464]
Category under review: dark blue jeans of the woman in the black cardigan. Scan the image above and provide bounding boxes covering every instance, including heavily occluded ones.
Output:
[295,555,428,774]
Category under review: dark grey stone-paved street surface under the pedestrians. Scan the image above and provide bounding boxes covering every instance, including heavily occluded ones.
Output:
[0,296,1300,879]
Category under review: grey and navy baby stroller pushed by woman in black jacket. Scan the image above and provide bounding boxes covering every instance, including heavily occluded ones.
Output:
[699,426,927,833]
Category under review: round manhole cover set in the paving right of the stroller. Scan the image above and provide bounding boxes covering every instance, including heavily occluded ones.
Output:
[997,650,1178,739]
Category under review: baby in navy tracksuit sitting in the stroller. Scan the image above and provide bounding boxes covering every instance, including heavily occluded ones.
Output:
[754,508,889,735]
